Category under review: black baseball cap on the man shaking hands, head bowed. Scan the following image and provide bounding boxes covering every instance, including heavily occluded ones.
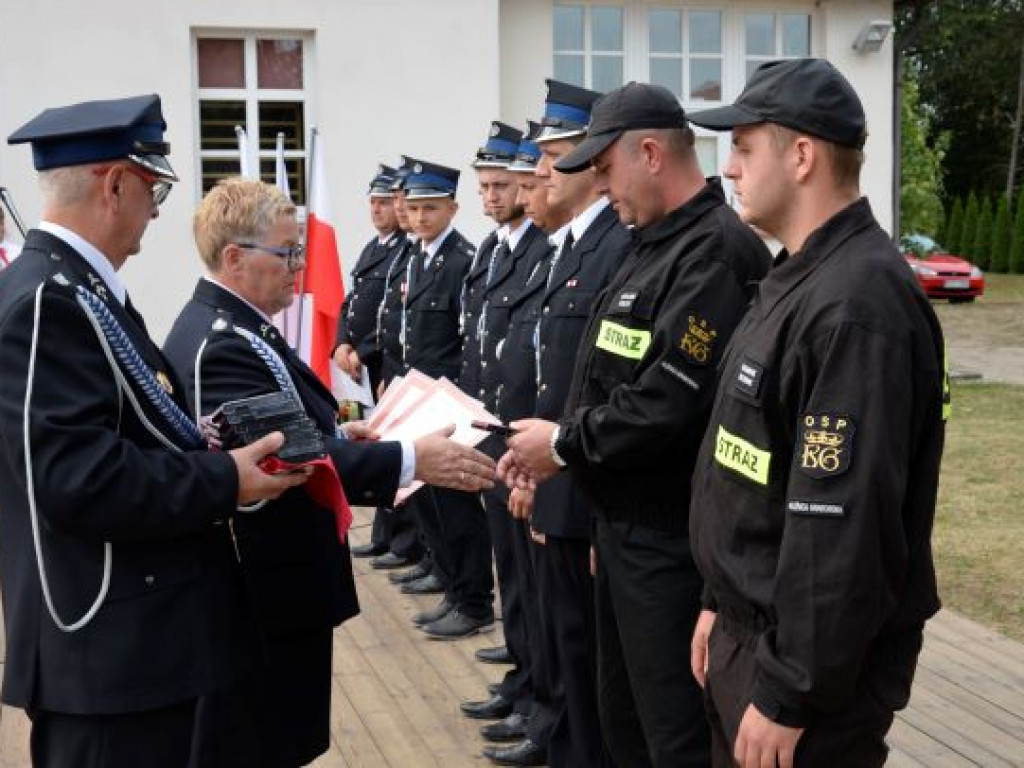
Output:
[555,83,686,173]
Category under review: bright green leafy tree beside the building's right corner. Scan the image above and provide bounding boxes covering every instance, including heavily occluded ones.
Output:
[899,68,949,239]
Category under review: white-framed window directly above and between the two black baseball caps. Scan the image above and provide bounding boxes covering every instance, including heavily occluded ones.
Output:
[647,8,723,102]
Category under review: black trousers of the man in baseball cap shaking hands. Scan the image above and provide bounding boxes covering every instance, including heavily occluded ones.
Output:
[596,517,711,768]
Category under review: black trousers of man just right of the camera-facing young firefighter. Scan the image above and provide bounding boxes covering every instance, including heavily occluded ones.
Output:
[483,487,534,715]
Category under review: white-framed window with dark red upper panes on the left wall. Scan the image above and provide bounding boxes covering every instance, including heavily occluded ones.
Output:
[194,30,312,206]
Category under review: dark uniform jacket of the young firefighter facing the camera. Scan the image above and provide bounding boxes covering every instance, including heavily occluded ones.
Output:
[406,229,476,382]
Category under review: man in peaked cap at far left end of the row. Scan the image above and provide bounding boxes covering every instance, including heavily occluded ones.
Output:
[334,165,419,557]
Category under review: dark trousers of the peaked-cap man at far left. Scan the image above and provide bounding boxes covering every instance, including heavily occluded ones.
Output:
[30,698,196,768]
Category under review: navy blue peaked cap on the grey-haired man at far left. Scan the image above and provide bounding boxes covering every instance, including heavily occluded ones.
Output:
[7,93,178,181]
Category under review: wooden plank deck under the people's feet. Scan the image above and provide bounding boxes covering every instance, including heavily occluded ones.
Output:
[0,510,1024,768]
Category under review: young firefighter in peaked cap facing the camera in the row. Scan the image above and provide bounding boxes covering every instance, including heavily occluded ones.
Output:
[402,161,495,640]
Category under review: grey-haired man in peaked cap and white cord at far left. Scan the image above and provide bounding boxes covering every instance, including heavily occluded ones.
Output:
[0,95,305,768]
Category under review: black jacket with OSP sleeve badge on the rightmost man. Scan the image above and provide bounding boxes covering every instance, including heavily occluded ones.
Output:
[690,199,948,724]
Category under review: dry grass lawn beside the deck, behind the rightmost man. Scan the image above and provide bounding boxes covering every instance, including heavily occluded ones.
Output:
[933,380,1024,641]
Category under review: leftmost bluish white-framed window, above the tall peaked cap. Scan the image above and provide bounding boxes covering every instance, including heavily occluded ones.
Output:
[553,4,626,91]
